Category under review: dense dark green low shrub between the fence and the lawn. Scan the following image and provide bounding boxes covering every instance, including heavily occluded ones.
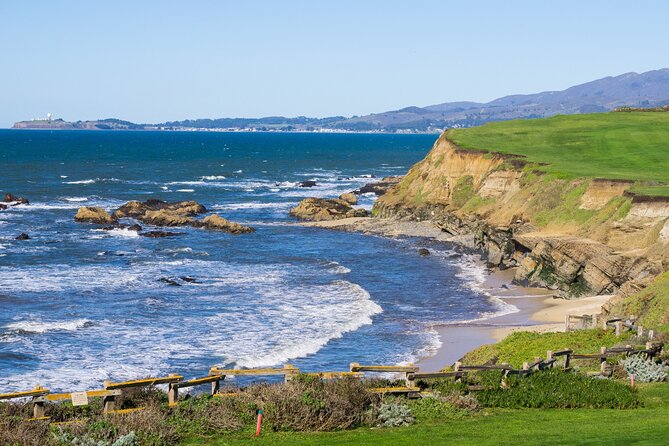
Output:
[477,369,639,409]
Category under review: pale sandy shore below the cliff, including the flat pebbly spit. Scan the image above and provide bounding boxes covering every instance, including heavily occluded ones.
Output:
[300,217,611,372]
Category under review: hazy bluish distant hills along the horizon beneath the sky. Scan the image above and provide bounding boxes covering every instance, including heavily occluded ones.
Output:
[14,68,669,133]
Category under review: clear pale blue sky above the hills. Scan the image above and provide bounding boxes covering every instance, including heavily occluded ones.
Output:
[0,0,669,127]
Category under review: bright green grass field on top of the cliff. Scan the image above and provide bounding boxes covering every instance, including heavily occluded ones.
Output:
[447,113,669,187]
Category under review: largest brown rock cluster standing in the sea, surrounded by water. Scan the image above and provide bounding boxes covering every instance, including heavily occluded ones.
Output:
[74,199,254,233]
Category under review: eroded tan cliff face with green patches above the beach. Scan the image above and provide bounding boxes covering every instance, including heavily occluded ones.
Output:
[373,134,669,297]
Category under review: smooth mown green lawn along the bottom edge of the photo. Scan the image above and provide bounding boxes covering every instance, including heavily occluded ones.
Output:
[182,383,669,446]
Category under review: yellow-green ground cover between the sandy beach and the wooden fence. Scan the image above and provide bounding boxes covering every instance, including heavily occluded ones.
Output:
[463,329,629,367]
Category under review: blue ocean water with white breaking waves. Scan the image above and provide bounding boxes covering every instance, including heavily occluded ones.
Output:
[0,130,504,391]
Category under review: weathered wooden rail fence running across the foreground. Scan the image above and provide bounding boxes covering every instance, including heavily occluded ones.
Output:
[0,341,663,420]
